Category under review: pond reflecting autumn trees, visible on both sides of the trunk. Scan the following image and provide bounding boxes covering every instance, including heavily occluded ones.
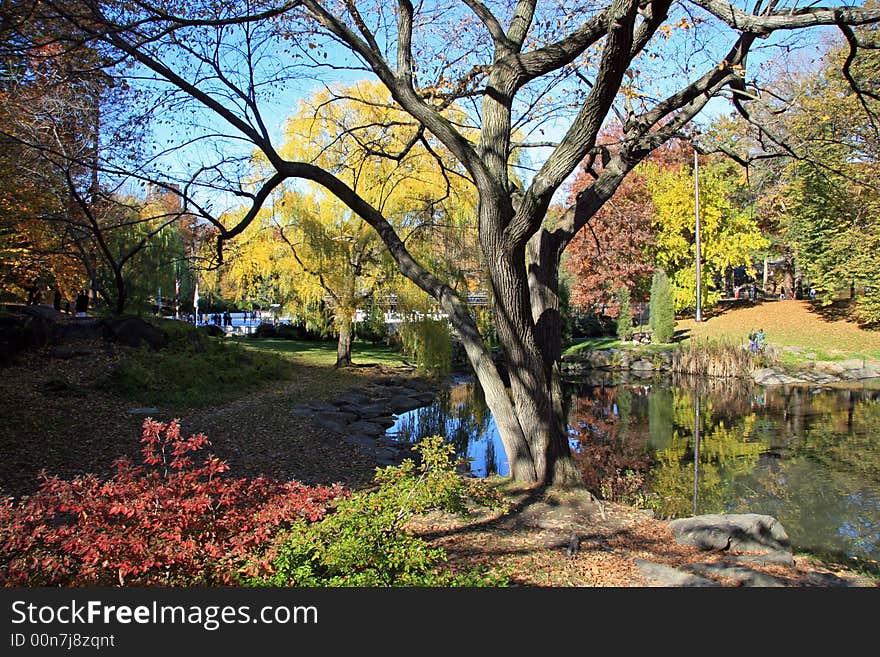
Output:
[388,374,880,562]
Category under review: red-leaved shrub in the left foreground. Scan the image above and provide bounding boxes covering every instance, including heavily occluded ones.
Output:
[0,419,347,586]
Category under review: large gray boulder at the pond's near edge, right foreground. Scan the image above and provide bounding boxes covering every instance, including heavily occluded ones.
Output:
[669,513,791,555]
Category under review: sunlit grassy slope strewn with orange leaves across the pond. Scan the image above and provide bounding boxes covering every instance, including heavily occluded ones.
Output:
[675,300,880,362]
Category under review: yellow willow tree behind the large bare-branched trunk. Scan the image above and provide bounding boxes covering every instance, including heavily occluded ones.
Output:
[237,82,476,367]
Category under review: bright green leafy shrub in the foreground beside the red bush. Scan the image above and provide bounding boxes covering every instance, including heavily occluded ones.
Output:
[251,436,507,587]
